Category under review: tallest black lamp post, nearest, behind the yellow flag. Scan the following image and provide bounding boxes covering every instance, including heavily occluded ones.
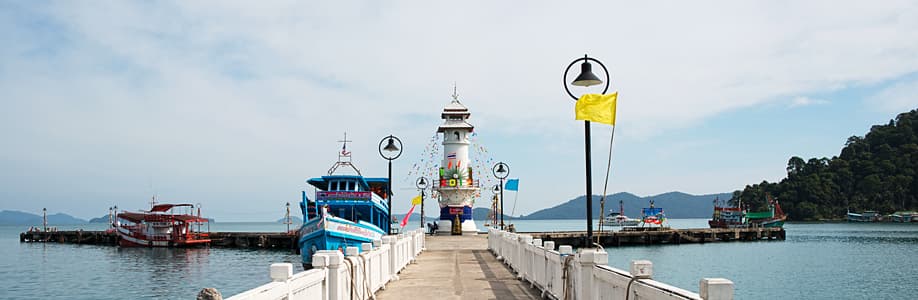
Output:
[561,54,610,244]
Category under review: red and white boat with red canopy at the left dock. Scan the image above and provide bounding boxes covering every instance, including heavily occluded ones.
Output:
[115,204,210,247]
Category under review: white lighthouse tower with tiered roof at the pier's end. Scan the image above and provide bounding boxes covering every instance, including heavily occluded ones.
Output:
[435,88,479,234]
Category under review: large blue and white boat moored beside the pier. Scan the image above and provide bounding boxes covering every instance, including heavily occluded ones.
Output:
[299,144,391,269]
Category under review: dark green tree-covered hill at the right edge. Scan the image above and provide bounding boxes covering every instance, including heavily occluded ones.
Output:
[731,110,918,220]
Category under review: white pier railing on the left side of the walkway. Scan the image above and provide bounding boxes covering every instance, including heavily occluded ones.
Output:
[227,229,424,300]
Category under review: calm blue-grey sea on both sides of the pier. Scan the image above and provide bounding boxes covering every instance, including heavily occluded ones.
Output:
[0,219,918,299]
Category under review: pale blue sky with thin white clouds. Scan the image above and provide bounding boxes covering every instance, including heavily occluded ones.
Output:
[0,0,918,221]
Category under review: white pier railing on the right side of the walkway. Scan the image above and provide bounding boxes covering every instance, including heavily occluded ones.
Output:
[488,228,733,300]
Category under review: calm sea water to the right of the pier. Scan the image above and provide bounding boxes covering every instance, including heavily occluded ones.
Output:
[514,219,918,299]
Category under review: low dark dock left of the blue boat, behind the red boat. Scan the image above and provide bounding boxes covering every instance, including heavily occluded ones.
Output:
[19,230,299,252]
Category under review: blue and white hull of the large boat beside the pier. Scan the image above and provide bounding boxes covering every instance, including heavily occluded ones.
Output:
[298,217,385,266]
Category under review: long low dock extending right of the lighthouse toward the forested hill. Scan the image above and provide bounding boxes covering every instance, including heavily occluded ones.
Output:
[524,227,785,248]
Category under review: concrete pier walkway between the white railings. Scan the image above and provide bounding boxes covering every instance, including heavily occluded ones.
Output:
[376,234,541,300]
